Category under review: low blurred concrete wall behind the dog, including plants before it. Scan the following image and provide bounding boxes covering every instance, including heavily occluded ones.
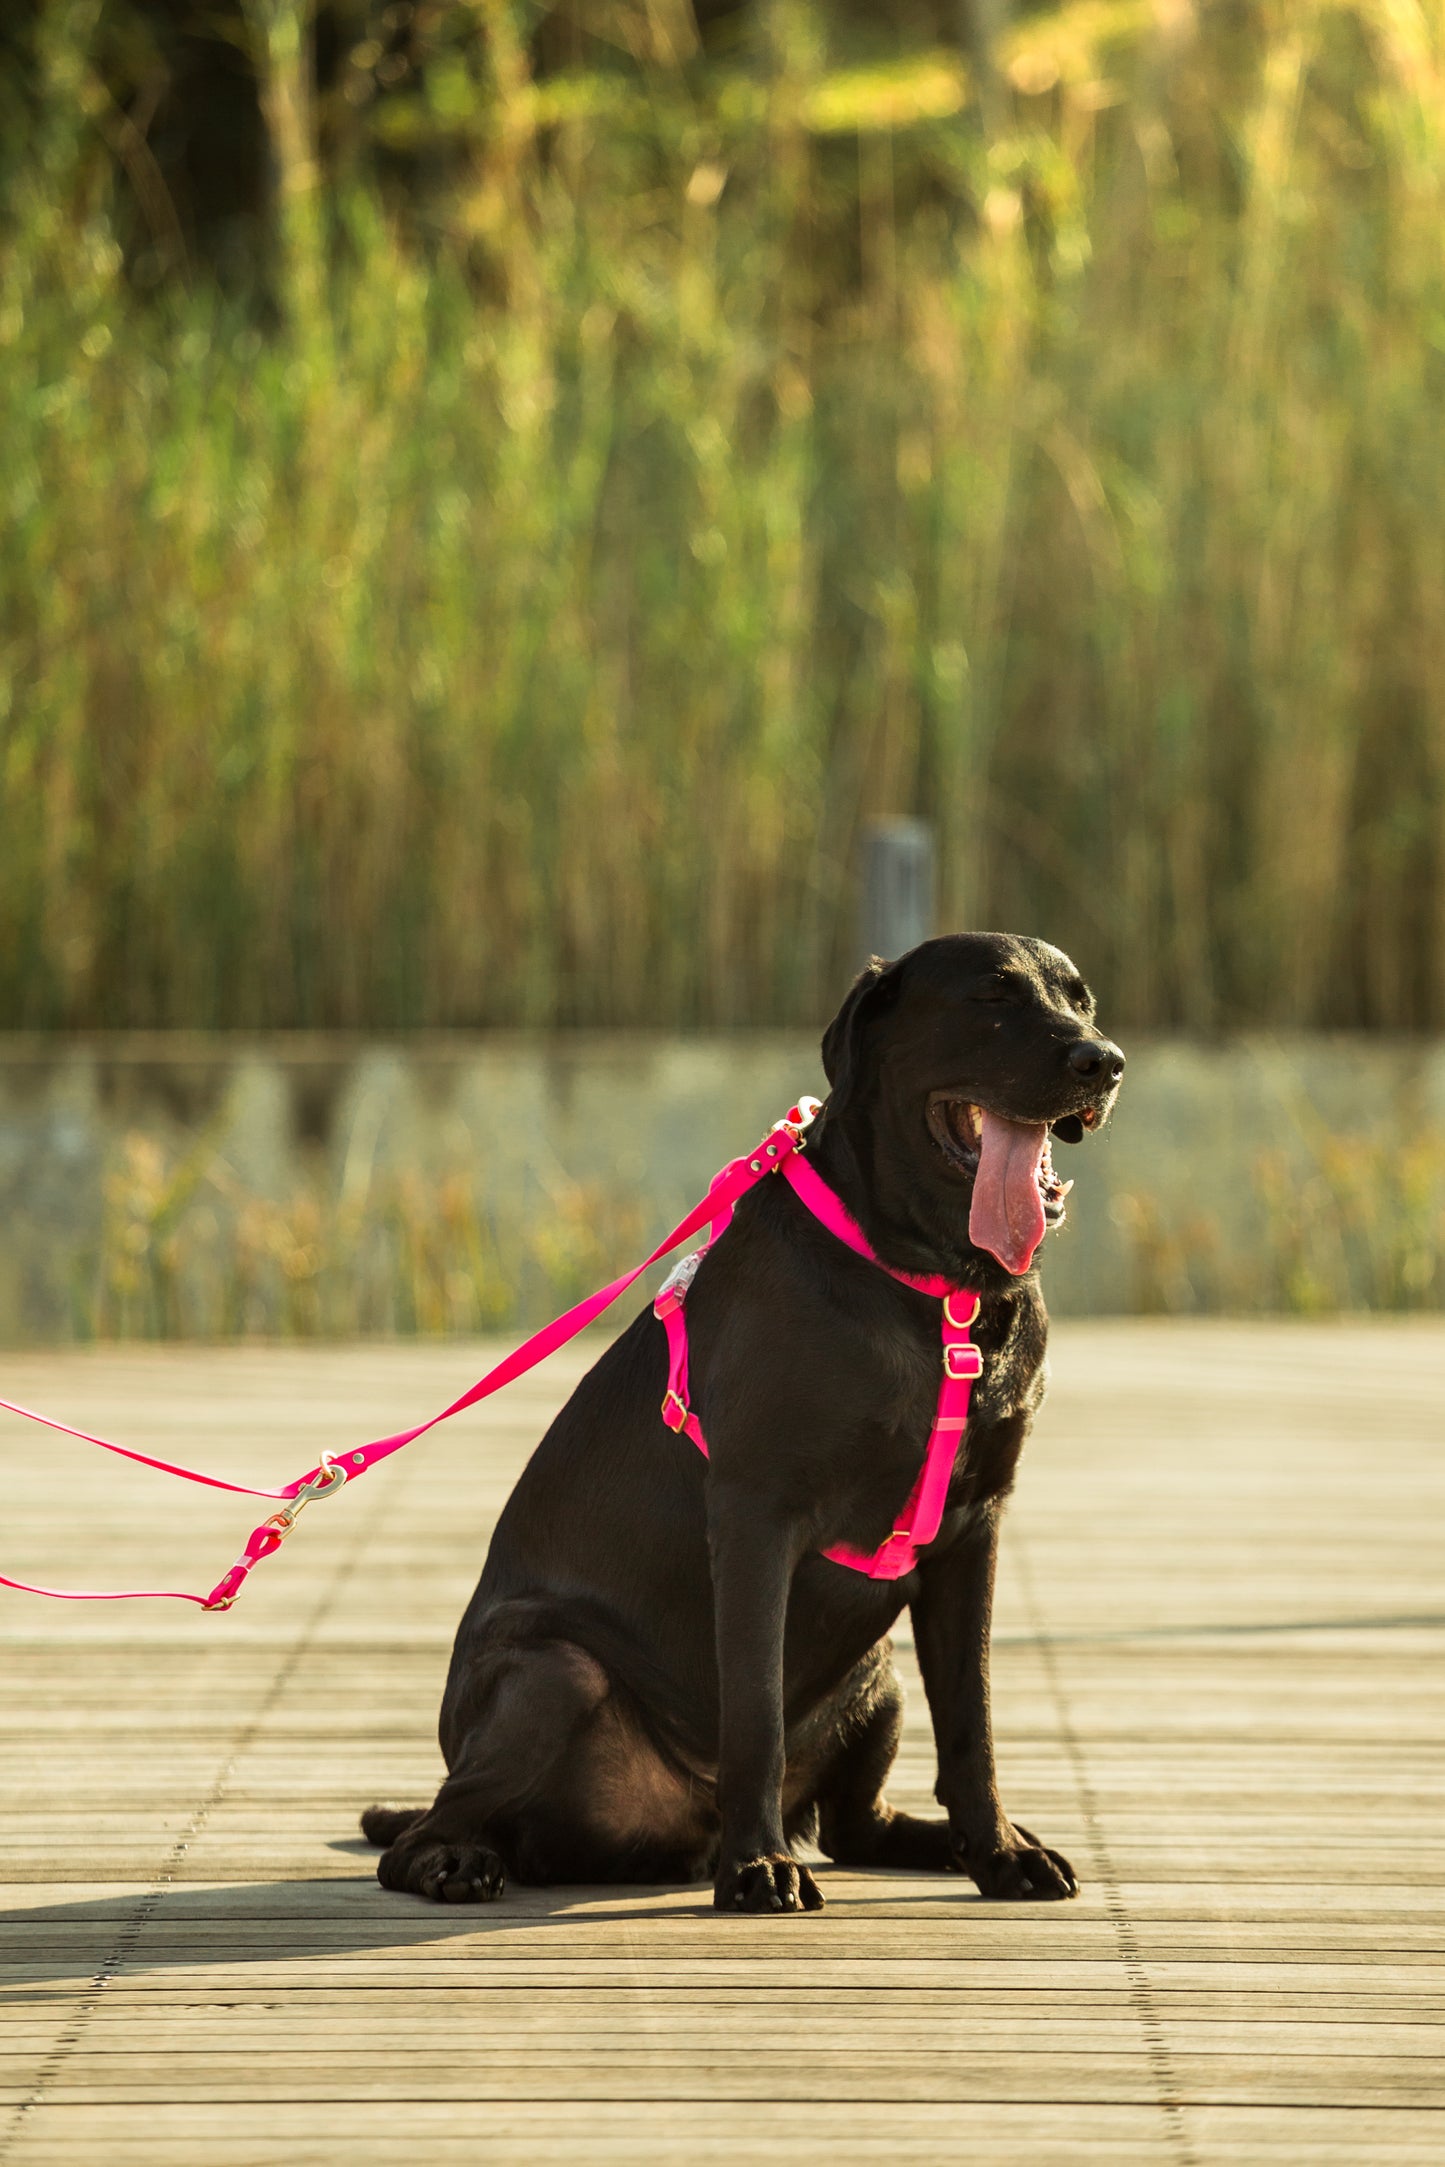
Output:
[0,1031,1445,1344]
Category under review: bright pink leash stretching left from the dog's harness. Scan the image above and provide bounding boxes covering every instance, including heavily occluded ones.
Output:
[0,1099,817,1610]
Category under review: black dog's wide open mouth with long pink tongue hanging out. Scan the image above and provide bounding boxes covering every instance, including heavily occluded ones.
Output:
[927,1092,1101,1274]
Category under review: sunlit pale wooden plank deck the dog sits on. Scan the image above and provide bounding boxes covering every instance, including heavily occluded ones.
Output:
[0,1324,1445,2167]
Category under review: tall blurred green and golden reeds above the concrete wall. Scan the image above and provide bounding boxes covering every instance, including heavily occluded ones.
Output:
[0,0,1445,1031]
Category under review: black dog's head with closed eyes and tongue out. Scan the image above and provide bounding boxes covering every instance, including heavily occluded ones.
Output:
[823,934,1124,1276]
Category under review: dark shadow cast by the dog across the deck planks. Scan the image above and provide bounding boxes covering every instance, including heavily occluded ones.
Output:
[0,1842,996,2009]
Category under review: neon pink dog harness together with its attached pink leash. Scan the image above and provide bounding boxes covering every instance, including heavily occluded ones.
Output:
[0,1099,981,1610]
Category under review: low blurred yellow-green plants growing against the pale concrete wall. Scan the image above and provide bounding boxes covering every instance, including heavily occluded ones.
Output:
[87,1125,1445,1341]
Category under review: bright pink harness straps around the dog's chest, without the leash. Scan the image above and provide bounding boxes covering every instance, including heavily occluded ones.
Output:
[652,1153,984,1580]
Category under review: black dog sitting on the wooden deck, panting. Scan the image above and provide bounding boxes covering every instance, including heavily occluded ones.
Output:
[362,934,1124,1911]
